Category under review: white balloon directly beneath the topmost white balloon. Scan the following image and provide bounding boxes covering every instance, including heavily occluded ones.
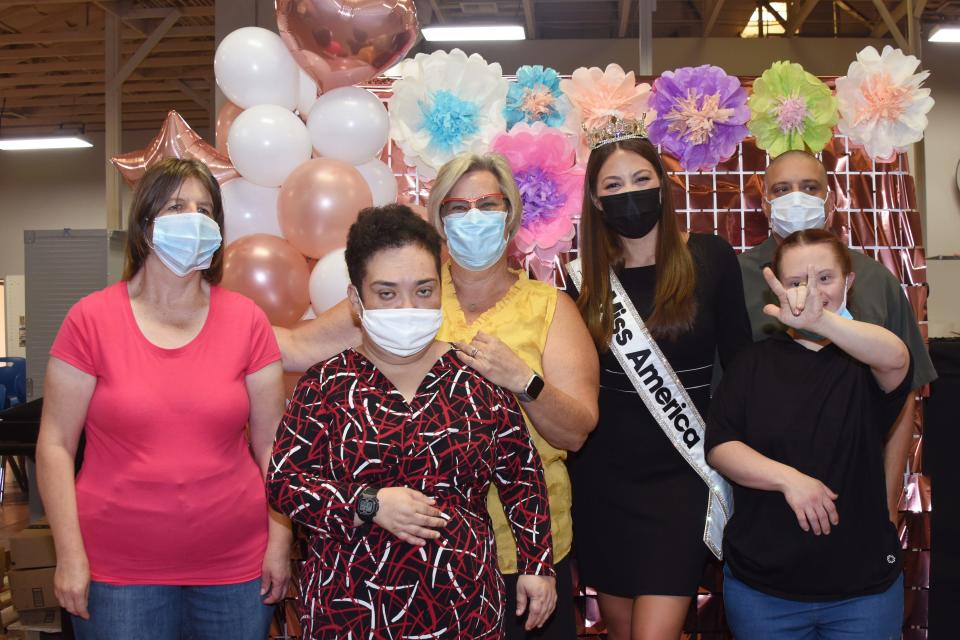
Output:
[227,104,311,187]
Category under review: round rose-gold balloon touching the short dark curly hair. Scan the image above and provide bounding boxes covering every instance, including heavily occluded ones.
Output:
[277,158,373,258]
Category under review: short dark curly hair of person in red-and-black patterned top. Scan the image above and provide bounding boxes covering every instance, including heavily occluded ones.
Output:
[344,204,440,292]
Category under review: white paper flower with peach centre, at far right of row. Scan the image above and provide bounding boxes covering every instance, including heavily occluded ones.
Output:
[836,45,933,160]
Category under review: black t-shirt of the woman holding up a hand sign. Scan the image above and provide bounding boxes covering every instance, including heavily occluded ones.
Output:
[706,333,912,601]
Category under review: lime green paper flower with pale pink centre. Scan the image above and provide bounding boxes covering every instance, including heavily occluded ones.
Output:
[747,60,838,156]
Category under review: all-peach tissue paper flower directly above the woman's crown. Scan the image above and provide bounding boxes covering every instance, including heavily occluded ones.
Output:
[560,63,654,161]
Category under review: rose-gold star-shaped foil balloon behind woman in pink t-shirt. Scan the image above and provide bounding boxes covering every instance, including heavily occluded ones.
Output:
[110,111,240,187]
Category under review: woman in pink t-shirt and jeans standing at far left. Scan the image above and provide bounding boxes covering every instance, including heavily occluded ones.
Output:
[37,159,291,640]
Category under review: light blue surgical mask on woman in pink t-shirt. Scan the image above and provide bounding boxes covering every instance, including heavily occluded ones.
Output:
[152,213,222,278]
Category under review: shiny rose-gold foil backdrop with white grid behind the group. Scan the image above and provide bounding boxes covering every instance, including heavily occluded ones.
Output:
[270,78,930,640]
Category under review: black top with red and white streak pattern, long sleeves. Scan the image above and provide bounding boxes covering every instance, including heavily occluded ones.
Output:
[267,349,553,639]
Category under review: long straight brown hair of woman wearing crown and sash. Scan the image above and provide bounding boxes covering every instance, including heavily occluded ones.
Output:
[577,138,697,352]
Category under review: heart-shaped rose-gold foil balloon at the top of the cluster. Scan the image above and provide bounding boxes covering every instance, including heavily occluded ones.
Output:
[276,0,420,91]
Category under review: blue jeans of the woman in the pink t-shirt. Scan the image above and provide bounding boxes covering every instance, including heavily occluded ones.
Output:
[72,578,273,640]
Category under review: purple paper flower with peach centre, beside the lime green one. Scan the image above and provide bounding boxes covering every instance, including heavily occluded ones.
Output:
[648,64,750,171]
